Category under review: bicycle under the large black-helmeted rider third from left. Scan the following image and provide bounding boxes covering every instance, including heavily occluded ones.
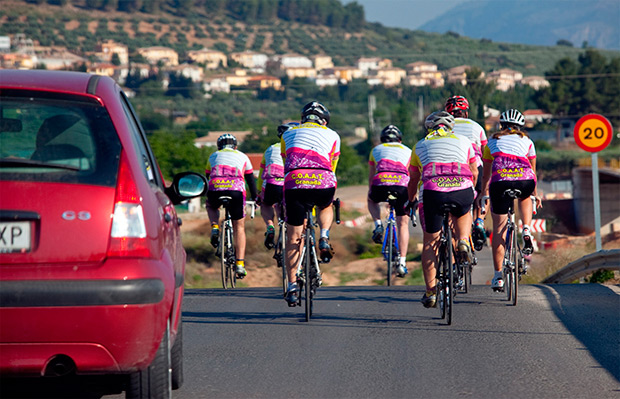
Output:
[296,199,340,321]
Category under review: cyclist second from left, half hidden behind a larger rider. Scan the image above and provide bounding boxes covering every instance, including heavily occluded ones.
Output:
[257,122,299,249]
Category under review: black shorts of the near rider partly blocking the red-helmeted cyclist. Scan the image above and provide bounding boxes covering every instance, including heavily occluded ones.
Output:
[420,188,474,234]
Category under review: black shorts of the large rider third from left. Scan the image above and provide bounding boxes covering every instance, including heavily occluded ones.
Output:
[284,187,336,226]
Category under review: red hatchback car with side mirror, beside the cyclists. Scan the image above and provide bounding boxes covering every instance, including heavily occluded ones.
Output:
[0,70,206,398]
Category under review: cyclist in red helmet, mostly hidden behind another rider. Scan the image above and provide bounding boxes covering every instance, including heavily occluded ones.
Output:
[445,96,487,251]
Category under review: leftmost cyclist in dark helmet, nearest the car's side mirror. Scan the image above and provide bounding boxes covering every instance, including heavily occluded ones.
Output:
[205,133,256,279]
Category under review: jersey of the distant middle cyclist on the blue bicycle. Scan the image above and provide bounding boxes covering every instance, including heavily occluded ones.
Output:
[368,143,411,187]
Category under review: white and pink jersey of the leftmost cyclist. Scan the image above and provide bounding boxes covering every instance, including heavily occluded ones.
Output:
[205,148,256,195]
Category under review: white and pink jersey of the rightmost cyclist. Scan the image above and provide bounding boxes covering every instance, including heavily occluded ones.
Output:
[482,134,536,183]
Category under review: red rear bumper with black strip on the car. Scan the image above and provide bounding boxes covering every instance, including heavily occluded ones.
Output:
[0,259,179,375]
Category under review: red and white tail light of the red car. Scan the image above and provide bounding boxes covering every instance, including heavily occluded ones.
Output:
[108,152,151,257]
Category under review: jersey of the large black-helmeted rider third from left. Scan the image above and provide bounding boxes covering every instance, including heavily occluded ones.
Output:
[281,122,340,190]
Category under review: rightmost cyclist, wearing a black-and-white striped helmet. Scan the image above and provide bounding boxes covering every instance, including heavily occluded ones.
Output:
[482,109,542,290]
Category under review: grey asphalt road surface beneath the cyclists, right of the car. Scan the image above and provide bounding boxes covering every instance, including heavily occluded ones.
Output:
[174,284,620,399]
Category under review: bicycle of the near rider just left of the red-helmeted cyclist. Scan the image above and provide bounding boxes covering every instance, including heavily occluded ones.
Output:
[436,204,456,325]
